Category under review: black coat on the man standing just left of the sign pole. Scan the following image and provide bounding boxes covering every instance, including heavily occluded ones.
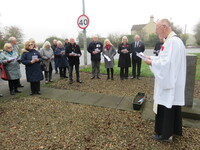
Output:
[65,44,82,65]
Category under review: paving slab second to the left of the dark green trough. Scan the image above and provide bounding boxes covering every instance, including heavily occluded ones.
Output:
[94,95,123,108]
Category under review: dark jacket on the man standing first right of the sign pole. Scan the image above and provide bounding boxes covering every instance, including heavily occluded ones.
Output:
[87,42,103,61]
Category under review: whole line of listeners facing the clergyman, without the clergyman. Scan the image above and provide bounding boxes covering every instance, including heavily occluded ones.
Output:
[0,35,145,95]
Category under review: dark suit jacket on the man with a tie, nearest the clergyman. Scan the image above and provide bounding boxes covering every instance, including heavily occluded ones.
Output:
[131,41,145,60]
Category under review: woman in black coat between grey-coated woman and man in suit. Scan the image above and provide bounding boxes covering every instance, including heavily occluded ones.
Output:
[118,36,131,80]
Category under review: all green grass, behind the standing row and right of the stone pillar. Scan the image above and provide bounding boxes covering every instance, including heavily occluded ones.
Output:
[80,53,200,80]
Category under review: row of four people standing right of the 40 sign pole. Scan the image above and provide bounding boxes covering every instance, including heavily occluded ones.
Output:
[88,35,145,80]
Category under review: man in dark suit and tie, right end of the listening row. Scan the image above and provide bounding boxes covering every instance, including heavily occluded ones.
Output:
[131,35,145,80]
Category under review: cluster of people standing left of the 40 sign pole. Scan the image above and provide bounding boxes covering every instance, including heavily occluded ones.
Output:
[0,37,82,96]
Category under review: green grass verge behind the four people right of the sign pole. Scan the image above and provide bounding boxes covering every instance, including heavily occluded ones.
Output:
[80,60,153,77]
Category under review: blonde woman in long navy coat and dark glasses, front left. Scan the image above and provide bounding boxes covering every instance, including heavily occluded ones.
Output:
[21,41,43,95]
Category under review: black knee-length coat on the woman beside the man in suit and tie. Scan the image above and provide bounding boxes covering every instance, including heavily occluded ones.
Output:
[118,43,131,68]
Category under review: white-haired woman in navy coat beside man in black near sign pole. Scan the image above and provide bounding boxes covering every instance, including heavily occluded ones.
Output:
[54,41,69,78]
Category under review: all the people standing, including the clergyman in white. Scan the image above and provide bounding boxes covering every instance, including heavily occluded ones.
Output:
[0,19,186,141]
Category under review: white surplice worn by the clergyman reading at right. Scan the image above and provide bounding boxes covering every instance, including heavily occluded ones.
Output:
[150,32,186,110]
